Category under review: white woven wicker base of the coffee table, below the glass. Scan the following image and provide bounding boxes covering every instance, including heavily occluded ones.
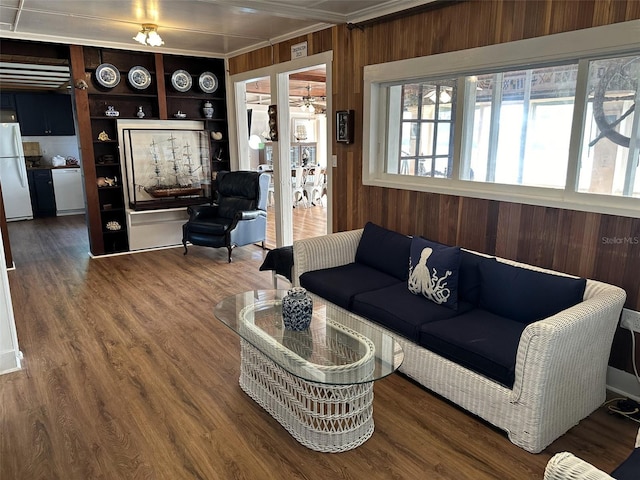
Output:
[240,339,373,453]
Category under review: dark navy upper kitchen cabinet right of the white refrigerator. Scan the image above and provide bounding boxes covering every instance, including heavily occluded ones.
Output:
[15,93,76,136]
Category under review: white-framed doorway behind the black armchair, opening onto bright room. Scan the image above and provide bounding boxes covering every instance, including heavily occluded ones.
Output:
[231,52,332,248]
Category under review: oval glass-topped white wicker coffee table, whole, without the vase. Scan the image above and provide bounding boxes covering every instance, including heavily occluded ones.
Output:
[215,290,404,452]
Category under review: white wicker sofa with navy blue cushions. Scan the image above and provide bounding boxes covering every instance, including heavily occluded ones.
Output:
[293,223,626,452]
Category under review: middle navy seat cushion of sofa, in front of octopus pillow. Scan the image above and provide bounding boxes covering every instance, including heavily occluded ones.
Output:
[352,282,473,342]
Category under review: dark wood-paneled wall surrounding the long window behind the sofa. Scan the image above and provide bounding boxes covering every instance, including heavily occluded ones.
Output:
[229,0,640,371]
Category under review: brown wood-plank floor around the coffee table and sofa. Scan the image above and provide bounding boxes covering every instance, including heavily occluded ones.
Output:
[0,217,638,480]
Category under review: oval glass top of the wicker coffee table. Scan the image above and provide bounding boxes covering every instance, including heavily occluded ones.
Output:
[215,290,404,385]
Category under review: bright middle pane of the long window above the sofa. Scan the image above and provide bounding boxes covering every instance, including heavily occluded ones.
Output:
[461,63,578,188]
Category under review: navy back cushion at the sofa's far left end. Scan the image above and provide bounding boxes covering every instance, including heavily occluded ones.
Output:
[356,222,411,280]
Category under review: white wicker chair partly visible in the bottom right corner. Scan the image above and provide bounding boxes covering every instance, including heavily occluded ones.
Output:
[544,430,640,480]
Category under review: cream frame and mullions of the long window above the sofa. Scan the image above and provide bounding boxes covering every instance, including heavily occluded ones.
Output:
[362,20,640,218]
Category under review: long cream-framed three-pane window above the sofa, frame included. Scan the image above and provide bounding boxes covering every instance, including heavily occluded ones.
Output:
[363,21,640,216]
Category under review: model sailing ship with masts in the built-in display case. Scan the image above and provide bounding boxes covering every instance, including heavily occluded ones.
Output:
[144,134,202,198]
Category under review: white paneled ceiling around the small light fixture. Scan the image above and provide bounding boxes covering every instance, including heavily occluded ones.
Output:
[0,0,435,58]
